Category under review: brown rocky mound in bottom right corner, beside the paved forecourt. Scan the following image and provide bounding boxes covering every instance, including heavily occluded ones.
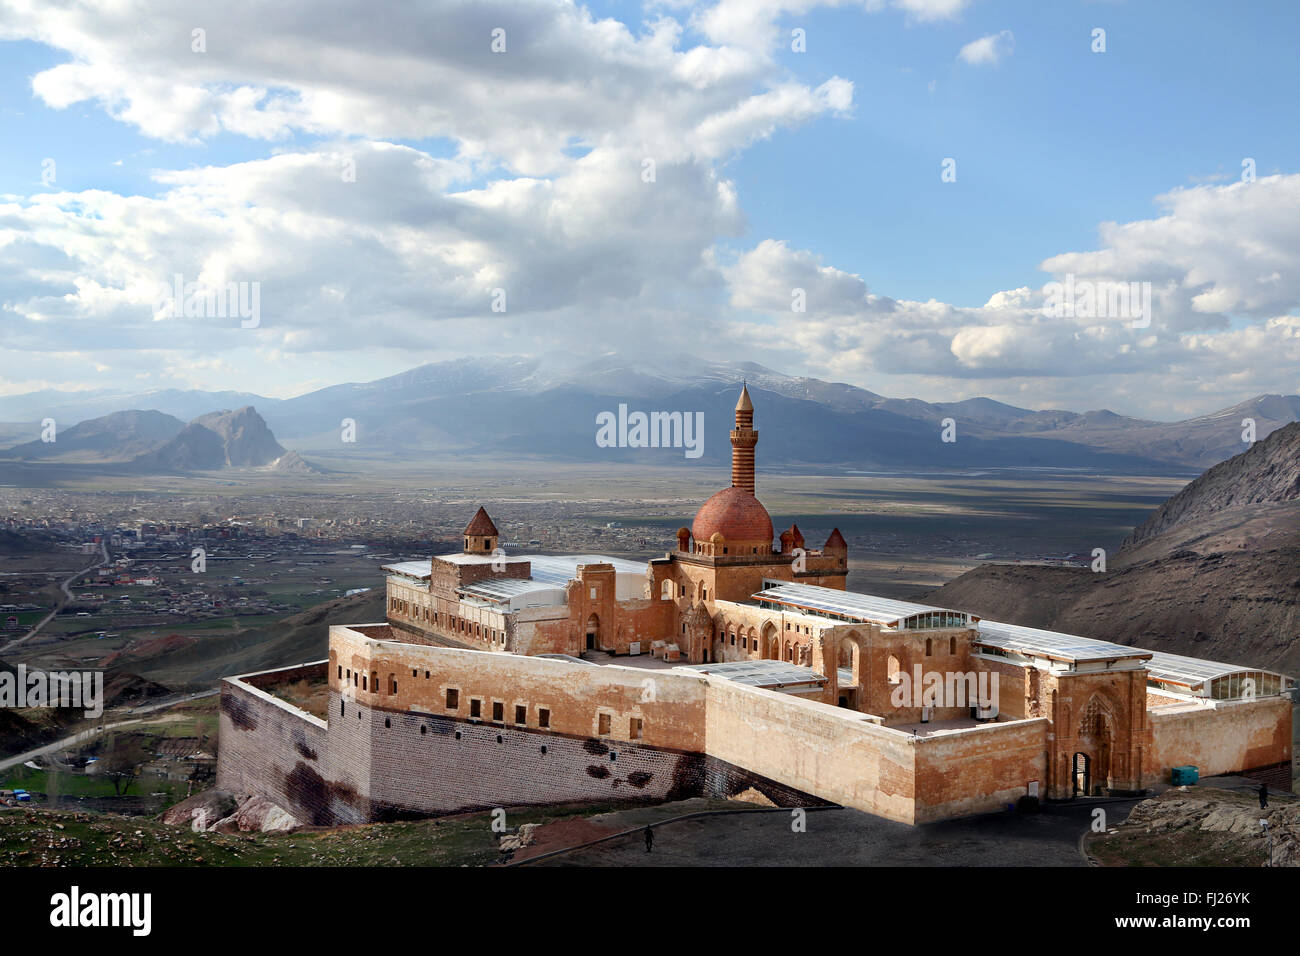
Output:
[1086,784,1300,866]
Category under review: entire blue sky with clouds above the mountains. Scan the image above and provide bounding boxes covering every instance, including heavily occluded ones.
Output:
[0,0,1300,419]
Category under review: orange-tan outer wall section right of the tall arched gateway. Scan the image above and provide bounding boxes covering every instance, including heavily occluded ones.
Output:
[1143,696,1291,786]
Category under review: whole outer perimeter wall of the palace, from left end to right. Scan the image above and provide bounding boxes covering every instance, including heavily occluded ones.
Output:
[218,626,1291,825]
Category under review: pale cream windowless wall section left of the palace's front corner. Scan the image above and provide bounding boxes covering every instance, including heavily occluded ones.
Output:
[706,679,915,823]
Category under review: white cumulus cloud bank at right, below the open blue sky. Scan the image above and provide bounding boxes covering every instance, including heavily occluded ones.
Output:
[723,176,1300,405]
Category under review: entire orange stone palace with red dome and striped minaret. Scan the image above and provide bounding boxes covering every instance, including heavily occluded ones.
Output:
[217,389,1291,825]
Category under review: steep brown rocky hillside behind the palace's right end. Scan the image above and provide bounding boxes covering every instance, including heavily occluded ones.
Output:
[923,425,1300,674]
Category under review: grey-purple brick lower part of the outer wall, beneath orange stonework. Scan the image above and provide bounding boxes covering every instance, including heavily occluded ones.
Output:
[217,662,826,826]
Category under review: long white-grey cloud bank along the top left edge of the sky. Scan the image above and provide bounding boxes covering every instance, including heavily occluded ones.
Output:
[0,0,852,176]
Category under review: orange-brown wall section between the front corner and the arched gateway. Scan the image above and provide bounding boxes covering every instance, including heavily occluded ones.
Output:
[915,717,1050,823]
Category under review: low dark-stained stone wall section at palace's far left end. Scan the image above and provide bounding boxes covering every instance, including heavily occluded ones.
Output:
[217,663,353,823]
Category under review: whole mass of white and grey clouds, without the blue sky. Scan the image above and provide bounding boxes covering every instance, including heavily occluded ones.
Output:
[0,0,1300,412]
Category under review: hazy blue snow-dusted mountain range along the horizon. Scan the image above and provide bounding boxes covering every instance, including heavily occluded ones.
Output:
[0,354,1300,475]
